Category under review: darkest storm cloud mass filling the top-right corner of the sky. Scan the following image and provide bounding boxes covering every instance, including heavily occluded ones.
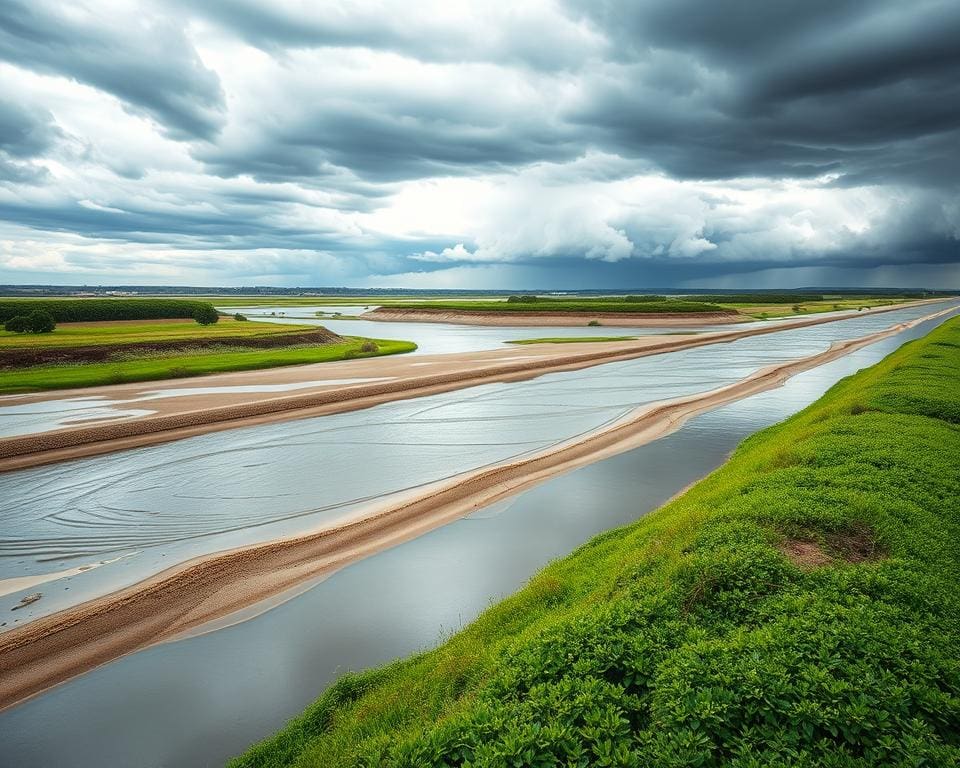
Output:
[572,0,960,185]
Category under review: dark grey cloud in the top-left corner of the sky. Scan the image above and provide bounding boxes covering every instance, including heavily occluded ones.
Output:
[0,0,225,139]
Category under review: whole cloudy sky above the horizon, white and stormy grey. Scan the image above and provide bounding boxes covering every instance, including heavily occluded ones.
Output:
[0,0,960,288]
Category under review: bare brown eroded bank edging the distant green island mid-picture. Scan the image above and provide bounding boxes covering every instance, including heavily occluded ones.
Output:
[359,307,751,328]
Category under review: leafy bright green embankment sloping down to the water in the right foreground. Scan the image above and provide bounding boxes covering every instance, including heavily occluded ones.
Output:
[232,320,960,768]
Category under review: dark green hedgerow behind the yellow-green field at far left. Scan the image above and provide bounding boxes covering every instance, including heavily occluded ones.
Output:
[0,298,217,323]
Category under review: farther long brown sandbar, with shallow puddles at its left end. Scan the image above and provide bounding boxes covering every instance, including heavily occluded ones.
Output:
[0,296,944,472]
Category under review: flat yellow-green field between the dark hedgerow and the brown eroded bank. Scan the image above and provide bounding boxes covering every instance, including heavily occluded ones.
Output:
[0,317,317,349]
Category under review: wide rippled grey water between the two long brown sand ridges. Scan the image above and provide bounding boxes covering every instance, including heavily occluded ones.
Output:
[0,306,952,628]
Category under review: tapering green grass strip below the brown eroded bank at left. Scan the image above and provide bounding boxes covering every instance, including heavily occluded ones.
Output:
[0,337,417,395]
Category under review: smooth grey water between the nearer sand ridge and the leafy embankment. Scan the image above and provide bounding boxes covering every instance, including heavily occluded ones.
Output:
[0,308,956,768]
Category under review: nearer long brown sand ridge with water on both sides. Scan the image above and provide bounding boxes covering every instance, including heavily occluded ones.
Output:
[0,304,941,708]
